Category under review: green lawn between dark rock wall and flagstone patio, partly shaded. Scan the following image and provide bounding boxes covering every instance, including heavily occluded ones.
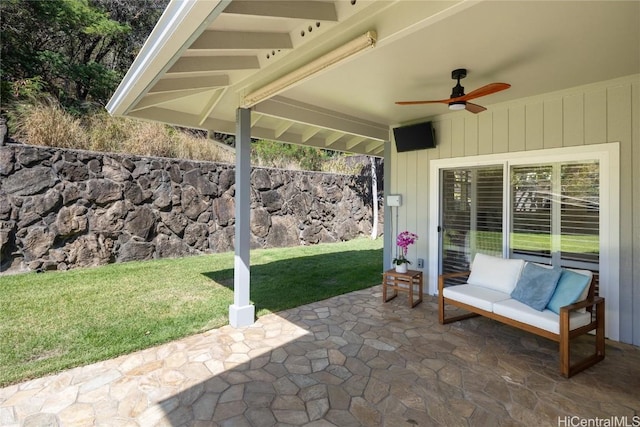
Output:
[0,238,382,386]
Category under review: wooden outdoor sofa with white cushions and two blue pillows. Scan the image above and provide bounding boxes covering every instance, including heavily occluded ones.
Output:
[438,253,605,378]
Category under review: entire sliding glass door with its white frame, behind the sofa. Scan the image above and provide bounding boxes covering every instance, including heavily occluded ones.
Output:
[427,142,621,339]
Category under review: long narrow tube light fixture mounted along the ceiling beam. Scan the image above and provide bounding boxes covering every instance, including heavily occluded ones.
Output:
[242,31,377,108]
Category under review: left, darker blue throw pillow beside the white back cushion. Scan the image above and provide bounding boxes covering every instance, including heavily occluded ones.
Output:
[511,262,562,311]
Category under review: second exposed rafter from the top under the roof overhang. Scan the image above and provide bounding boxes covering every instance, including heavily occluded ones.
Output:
[189,30,293,50]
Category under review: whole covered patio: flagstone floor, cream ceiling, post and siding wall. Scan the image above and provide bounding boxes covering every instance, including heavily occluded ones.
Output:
[0,0,640,427]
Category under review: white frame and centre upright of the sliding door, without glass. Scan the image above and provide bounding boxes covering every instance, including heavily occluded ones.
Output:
[427,142,620,340]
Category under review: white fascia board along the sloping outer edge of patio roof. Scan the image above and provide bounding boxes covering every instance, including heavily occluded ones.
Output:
[106,0,226,116]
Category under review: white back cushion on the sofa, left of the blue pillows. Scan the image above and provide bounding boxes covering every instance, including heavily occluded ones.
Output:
[467,253,524,294]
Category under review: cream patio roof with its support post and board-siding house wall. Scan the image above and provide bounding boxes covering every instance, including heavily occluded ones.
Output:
[107,0,640,345]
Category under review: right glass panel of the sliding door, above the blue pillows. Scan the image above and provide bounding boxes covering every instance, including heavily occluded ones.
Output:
[509,161,600,270]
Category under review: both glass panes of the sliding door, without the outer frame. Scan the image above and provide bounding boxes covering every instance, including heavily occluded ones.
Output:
[439,161,600,273]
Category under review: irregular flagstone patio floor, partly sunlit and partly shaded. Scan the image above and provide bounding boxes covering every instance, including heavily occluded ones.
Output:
[0,286,640,427]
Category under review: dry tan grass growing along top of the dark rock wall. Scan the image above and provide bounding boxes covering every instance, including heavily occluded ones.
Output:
[10,100,362,175]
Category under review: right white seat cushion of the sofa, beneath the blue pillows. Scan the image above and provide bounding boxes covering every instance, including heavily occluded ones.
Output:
[493,299,591,334]
